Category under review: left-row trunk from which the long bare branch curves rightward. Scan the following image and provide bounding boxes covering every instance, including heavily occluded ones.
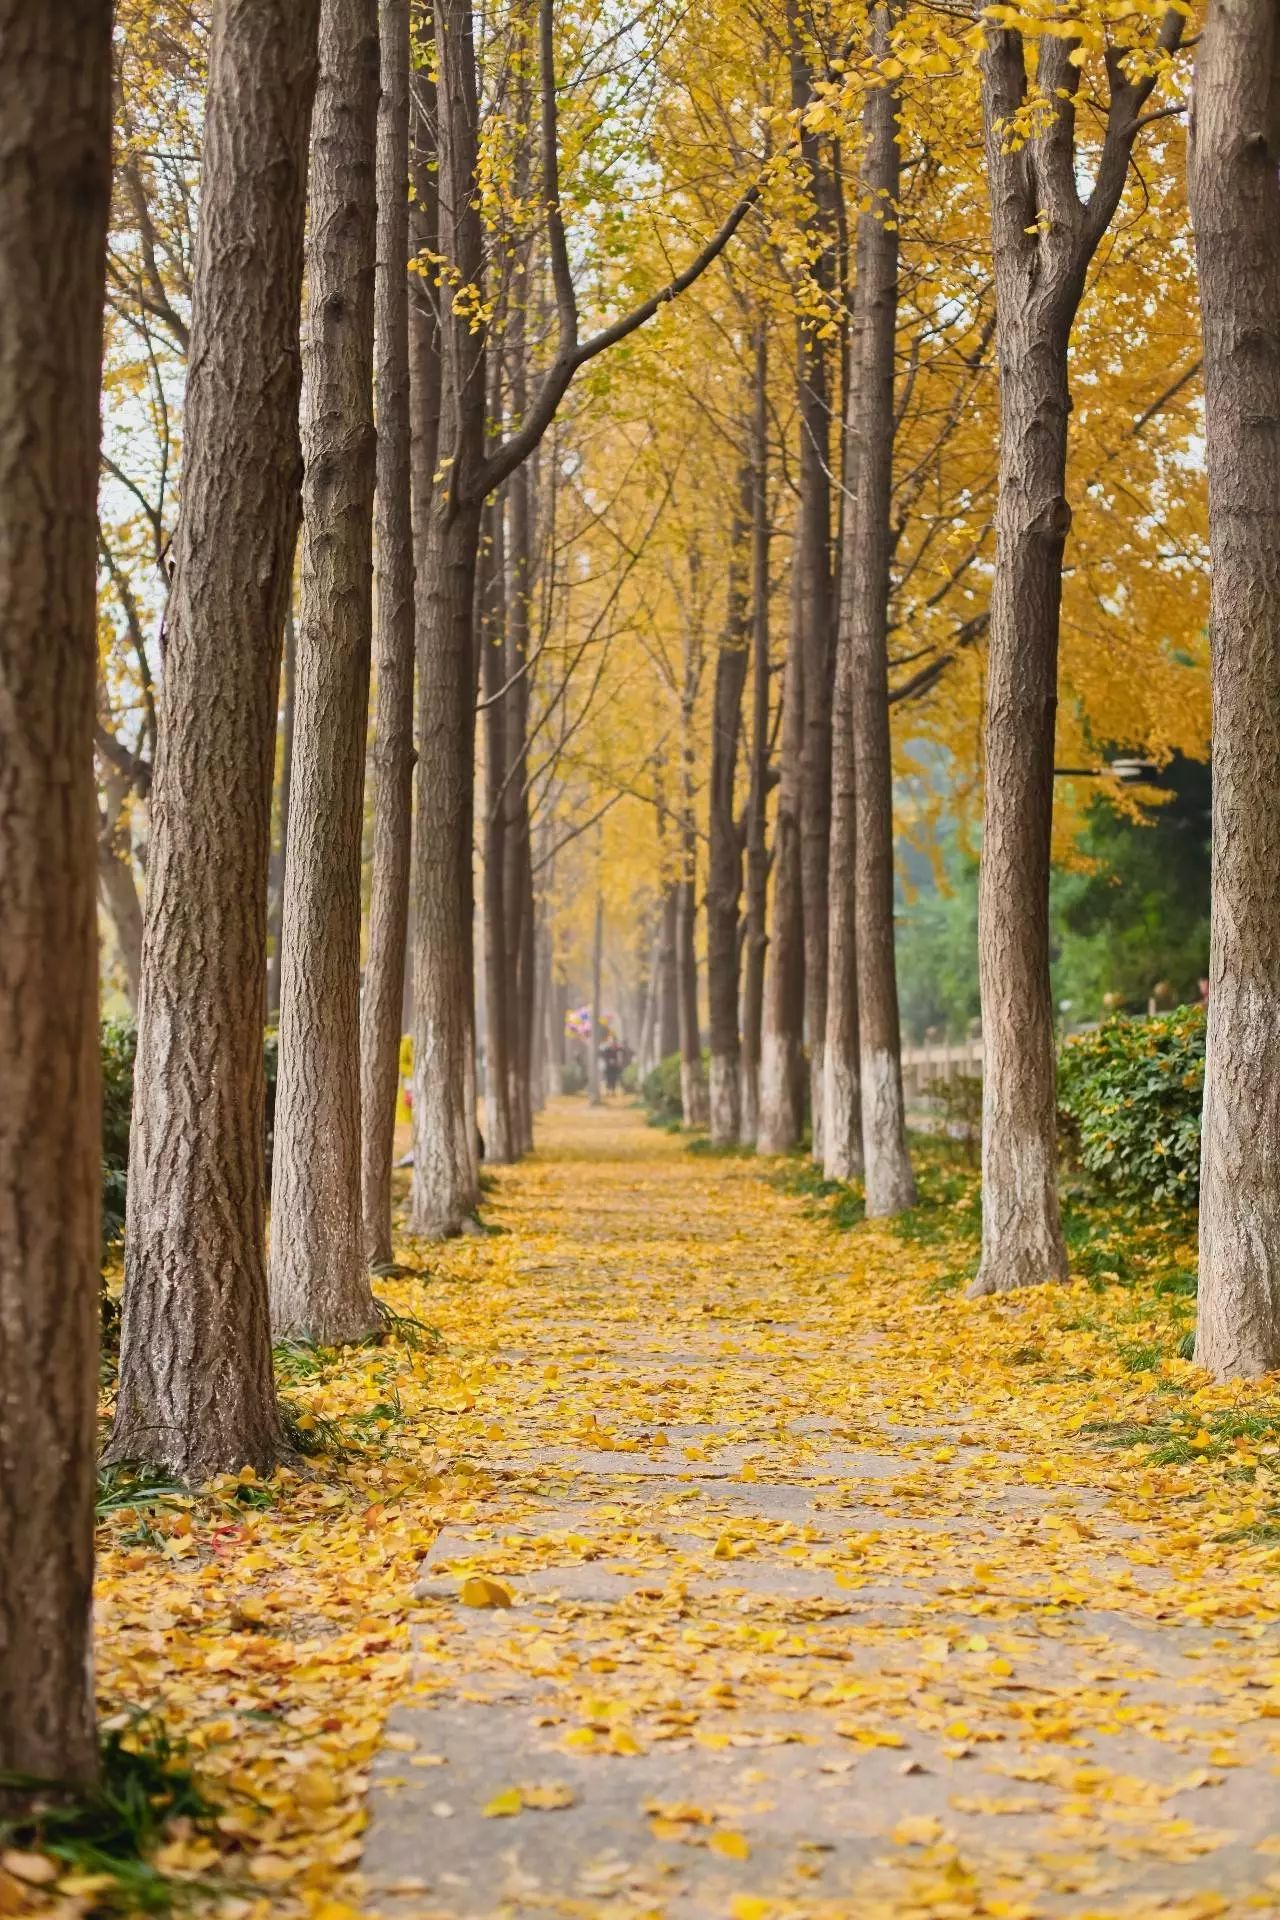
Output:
[411,0,486,1238]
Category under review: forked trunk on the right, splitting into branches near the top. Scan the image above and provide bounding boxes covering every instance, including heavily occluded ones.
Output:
[971,10,1182,1296]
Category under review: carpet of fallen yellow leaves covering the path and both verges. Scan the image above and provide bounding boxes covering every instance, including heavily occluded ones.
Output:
[75,1104,1280,1920]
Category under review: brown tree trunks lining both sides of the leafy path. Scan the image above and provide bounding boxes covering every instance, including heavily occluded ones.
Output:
[0,0,1280,1782]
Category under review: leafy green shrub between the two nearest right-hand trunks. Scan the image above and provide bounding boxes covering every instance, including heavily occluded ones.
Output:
[1057,1006,1205,1206]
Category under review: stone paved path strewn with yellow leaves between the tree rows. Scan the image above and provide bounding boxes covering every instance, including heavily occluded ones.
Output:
[365,1106,1280,1920]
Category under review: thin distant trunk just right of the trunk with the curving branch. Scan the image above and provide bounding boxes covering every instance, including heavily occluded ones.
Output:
[480,499,516,1165]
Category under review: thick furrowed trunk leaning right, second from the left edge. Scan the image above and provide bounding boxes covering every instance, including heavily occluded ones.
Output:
[107,0,319,1480]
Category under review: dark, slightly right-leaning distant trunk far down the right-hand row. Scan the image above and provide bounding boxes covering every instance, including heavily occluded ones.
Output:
[706,467,754,1146]
